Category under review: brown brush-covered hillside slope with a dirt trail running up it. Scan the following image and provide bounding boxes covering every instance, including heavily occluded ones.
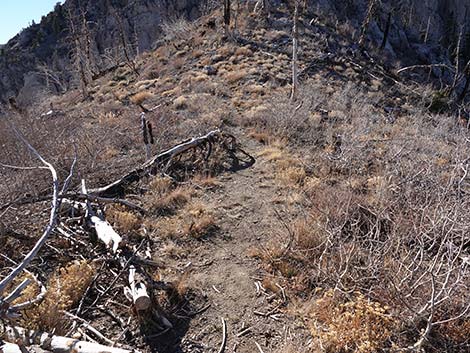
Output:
[0,1,470,353]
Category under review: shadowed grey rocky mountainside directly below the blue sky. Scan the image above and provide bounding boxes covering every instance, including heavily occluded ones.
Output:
[0,0,205,102]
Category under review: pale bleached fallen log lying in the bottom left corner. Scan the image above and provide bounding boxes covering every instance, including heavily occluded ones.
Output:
[0,326,137,353]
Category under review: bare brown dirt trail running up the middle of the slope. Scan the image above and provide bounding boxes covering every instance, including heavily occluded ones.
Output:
[156,131,308,353]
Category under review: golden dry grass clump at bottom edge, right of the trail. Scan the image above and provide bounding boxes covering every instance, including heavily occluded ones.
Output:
[309,290,398,353]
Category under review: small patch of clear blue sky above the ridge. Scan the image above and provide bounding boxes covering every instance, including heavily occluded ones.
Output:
[0,0,63,44]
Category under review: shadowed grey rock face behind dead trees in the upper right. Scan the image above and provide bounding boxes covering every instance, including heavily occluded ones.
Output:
[309,0,470,64]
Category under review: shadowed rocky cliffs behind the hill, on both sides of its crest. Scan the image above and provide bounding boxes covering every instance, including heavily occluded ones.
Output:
[0,0,470,101]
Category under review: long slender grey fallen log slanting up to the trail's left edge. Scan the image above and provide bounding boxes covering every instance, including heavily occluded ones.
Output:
[89,130,221,196]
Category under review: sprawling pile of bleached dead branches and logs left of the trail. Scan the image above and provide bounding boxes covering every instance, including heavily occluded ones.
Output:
[0,119,248,353]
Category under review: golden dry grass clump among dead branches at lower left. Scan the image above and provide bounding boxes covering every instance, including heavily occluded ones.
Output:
[24,261,96,334]
